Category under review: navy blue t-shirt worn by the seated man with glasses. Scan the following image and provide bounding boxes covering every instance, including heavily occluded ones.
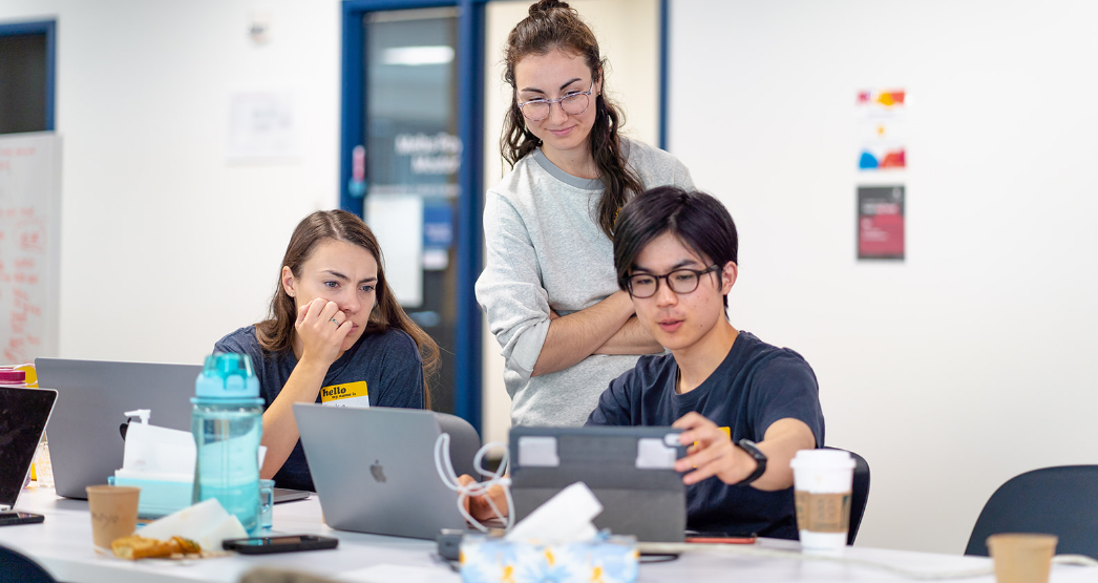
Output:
[587,332,824,540]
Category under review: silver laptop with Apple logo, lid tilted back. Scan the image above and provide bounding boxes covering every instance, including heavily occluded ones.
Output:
[293,403,467,540]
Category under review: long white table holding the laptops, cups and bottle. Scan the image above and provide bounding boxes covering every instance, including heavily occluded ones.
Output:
[0,491,1098,583]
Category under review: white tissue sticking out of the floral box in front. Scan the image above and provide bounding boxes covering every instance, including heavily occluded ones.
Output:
[506,482,603,545]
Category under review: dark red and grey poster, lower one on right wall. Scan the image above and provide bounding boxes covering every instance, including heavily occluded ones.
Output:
[858,186,904,259]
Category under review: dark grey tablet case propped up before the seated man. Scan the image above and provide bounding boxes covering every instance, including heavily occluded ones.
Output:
[511,427,686,542]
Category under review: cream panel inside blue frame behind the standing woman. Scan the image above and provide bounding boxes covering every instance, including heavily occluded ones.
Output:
[483,0,660,441]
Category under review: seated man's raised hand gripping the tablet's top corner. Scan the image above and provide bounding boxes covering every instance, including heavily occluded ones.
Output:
[671,411,757,485]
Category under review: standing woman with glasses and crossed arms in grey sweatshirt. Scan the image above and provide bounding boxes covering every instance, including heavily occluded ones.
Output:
[477,0,693,426]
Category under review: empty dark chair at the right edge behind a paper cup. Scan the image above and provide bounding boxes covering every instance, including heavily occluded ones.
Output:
[964,466,1098,559]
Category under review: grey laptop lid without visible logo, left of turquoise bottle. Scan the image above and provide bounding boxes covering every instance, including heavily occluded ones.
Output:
[34,358,202,500]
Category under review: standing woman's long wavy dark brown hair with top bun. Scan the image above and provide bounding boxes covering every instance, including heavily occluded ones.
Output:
[500,0,643,238]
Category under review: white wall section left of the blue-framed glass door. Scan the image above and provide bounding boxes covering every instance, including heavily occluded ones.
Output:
[0,0,339,362]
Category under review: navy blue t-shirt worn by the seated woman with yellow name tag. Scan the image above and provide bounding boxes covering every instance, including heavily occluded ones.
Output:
[214,326,424,492]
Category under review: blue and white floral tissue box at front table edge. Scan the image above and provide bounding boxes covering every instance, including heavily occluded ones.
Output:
[461,535,638,583]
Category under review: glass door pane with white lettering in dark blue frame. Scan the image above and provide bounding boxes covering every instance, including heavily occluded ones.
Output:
[350,8,462,413]
